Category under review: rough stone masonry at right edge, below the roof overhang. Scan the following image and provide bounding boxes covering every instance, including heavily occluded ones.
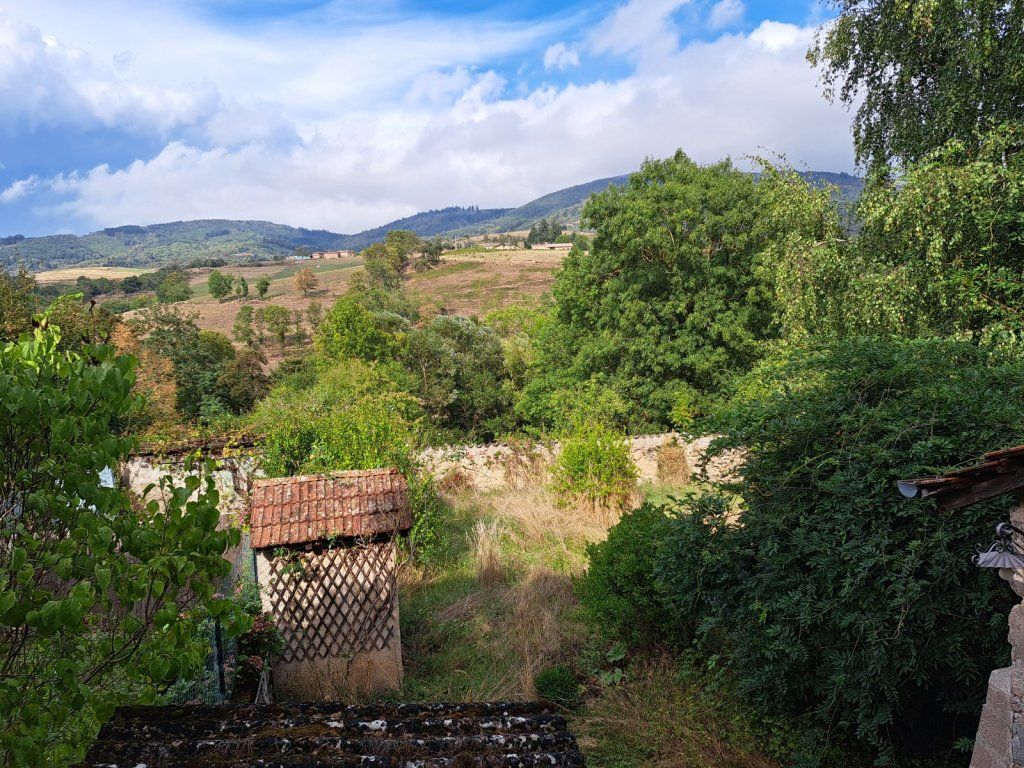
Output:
[971,505,1024,768]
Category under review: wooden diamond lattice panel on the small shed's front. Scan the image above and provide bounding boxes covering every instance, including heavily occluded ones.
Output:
[267,542,395,662]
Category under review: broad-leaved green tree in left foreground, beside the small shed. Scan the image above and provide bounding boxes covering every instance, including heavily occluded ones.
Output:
[0,327,245,765]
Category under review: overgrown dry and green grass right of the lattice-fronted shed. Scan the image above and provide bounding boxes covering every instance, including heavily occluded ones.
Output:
[389,477,774,768]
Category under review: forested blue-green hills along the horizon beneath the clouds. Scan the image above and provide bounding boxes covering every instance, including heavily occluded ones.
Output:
[6,171,863,271]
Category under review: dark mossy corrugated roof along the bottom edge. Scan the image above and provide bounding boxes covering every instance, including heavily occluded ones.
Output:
[82,702,584,768]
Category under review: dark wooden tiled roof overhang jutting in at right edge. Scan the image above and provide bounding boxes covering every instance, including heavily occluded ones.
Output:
[896,445,1024,510]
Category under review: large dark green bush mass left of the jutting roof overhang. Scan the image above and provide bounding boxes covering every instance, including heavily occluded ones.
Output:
[581,339,1024,764]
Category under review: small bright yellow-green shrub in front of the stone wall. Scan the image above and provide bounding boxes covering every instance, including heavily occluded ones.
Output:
[552,424,637,511]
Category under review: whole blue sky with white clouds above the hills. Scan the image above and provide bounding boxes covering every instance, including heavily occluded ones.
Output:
[0,0,853,234]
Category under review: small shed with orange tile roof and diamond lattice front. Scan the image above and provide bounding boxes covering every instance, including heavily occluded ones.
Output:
[250,469,413,700]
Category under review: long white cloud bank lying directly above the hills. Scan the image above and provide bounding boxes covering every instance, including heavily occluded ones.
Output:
[39,23,851,231]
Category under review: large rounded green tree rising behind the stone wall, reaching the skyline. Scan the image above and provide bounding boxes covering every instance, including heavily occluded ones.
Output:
[522,152,775,427]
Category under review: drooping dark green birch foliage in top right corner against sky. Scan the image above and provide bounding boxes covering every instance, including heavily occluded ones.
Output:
[809,0,1024,166]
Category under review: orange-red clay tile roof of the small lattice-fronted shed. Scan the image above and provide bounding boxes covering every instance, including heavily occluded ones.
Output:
[250,469,413,549]
